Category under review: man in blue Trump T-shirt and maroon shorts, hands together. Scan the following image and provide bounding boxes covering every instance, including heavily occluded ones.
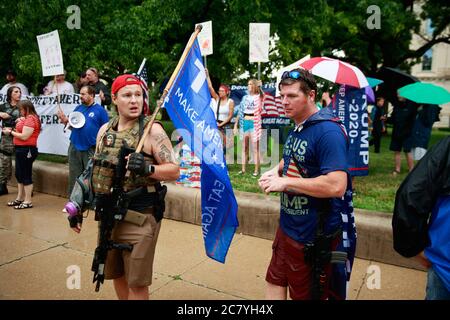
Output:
[259,69,356,300]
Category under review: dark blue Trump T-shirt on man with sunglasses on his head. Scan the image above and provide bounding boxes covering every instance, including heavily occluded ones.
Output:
[280,108,354,243]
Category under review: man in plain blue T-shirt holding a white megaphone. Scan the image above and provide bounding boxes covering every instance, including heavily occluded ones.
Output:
[58,86,109,195]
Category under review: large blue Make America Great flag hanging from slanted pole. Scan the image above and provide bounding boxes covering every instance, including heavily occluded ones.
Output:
[164,40,239,263]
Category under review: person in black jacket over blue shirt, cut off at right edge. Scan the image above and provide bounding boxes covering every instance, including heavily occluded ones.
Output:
[392,137,450,300]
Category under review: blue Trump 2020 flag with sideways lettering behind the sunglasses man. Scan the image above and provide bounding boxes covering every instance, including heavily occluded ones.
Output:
[332,85,369,177]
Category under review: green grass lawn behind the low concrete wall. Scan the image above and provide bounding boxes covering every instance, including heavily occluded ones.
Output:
[34,121,450,213]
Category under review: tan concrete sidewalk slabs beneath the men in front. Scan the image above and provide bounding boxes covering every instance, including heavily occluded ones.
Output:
[0,187,426,300]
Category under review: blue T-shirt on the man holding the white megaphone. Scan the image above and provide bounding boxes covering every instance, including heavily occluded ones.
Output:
[70,103,109,151]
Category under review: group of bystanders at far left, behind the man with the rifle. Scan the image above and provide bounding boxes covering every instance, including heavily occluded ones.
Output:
[0,68,111,209]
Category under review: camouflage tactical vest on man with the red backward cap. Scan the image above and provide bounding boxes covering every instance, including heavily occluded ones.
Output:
[92,117,158,194]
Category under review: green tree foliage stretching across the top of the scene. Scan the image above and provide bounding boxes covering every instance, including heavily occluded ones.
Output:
[0,0,450,98]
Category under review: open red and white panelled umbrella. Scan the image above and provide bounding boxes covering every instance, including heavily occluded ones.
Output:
[300,57,369,88]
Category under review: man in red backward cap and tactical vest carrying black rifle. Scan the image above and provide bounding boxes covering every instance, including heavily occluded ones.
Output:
[71,74,179,299]
